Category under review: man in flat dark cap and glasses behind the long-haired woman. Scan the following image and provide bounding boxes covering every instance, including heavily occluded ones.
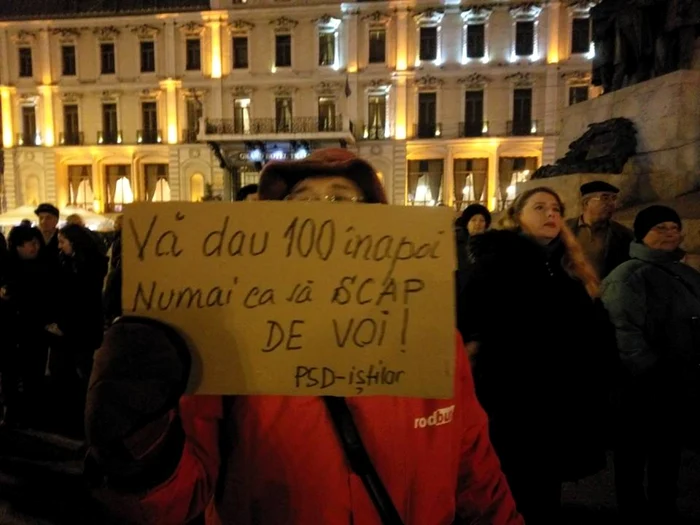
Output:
[567,180,633,279]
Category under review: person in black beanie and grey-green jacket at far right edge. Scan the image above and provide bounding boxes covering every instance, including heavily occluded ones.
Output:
[602,205,700,524]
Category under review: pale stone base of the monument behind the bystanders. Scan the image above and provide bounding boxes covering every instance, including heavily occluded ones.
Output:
[548,70,700,205]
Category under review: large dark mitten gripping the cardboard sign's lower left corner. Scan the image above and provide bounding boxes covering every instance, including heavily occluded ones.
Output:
[85,317,191,491]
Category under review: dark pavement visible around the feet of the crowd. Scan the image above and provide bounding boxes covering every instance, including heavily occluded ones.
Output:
[0,430,700,525]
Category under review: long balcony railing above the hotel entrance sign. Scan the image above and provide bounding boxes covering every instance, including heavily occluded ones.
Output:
[205,115,346,135]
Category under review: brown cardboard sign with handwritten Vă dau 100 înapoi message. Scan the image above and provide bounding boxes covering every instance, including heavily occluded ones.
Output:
[122,202,455,398]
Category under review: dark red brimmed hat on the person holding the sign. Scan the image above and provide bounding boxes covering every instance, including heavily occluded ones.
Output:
[258,148,387,204]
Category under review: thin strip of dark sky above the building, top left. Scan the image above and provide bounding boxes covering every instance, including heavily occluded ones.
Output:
[0,0,209,19]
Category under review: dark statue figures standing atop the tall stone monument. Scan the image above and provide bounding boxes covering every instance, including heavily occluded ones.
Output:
[591,0,700,93]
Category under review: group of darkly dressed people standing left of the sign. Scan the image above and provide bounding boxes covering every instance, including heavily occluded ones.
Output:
[0,203,121,437]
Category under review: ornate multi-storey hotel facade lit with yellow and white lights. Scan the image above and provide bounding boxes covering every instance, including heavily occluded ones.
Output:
[0,0,596,213]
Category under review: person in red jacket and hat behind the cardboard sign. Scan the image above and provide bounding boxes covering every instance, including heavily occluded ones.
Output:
[86,149,523,525]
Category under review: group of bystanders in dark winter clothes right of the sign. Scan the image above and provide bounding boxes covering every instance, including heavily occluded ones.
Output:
[456,181,700,524]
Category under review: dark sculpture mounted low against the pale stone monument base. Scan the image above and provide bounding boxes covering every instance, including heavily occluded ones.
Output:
[532,118,637,179]
